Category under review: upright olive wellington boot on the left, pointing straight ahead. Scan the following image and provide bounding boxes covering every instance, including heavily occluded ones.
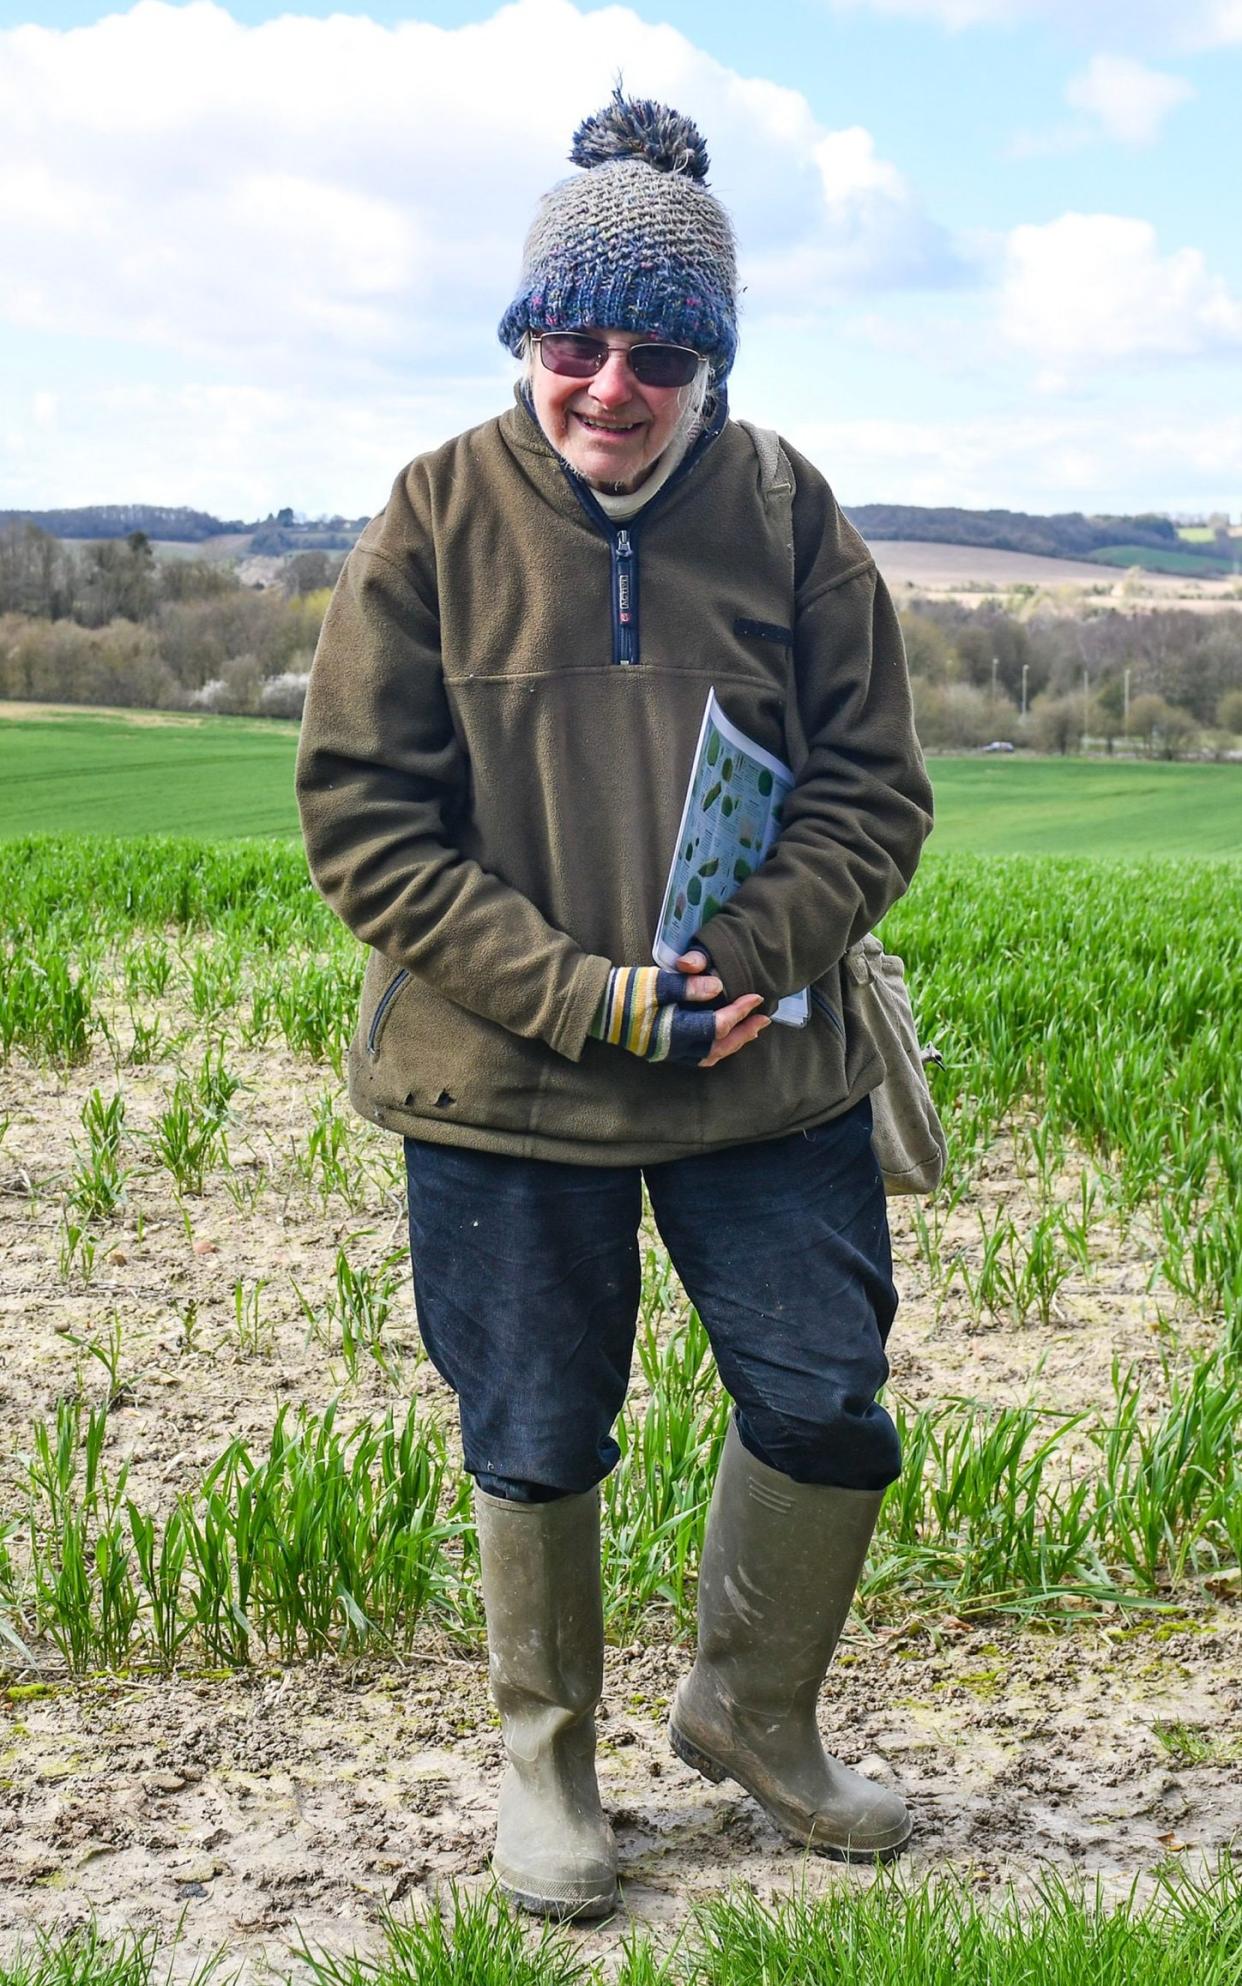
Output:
[475,1490,618,1916]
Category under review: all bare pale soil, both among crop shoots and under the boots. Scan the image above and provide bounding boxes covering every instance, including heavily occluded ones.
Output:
[0,987,1242,1982]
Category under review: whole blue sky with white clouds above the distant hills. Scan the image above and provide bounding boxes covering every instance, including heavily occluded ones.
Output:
[0,0,1242,518]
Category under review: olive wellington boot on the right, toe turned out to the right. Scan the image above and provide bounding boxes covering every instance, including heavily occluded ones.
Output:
[670,1426,910,1861]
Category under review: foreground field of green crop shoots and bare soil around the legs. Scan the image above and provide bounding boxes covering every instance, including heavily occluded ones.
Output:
[0,794,1242,1986]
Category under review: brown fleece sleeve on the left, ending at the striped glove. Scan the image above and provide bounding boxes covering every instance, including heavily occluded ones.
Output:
[296,479,610,1061]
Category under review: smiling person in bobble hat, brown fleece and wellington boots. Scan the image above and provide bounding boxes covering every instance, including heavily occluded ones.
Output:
[298,91,932,1916]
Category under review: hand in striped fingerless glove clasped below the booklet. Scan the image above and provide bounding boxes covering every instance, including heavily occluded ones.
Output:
[590,953,769,1068]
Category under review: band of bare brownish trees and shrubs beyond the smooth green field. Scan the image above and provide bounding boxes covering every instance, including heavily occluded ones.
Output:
[0,524,1242,757]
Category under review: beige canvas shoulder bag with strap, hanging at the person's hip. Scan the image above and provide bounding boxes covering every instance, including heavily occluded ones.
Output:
[739,421,948,1194]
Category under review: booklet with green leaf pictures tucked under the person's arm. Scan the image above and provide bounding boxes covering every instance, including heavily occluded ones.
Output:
[652,689,809,1027]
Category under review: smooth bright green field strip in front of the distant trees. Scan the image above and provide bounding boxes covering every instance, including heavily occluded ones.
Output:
[0,703,1242,856]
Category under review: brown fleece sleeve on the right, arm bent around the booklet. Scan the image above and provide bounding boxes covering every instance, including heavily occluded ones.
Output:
[687,449,932,1005]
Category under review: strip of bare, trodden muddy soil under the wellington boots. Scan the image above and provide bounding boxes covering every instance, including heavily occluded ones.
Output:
[0,1617,1242,1982]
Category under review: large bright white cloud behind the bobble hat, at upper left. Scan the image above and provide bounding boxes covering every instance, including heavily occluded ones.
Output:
[0,0,956,516]
